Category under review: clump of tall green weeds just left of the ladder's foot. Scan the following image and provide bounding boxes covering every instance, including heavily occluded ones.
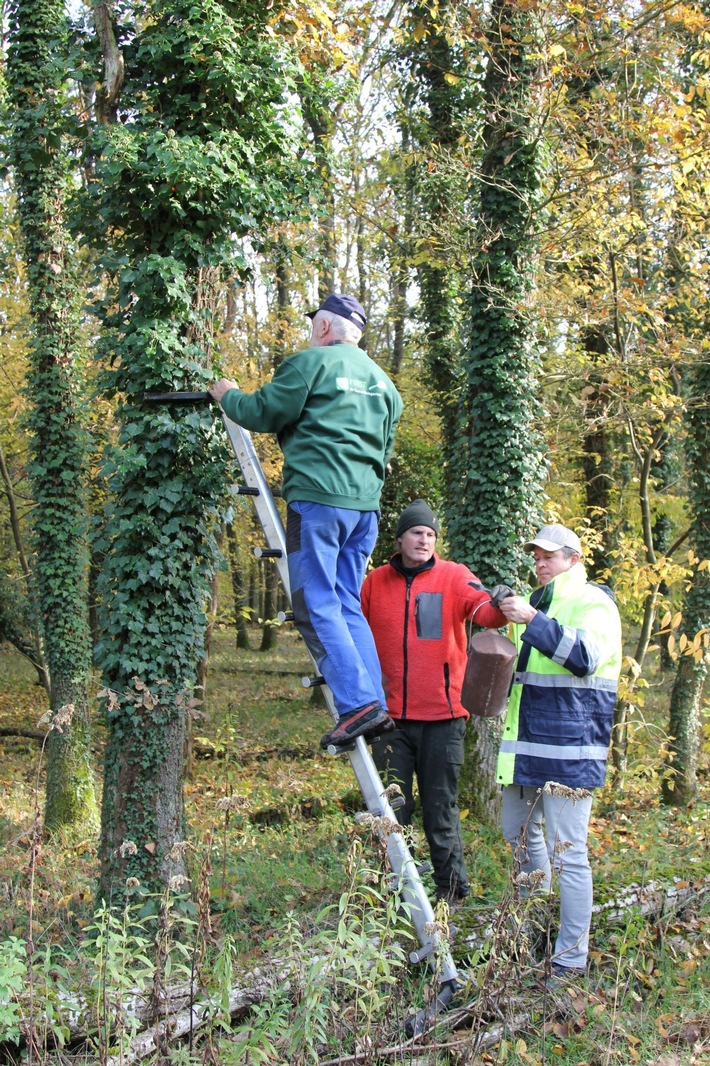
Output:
[219,840,422,1066]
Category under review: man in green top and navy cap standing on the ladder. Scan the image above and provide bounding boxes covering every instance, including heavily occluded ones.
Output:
[209,293,402,749]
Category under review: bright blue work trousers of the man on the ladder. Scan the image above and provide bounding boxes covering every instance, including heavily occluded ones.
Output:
[286,501,387,714]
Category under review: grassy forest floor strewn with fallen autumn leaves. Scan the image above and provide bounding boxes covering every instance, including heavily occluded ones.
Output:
[0,627,710,1066]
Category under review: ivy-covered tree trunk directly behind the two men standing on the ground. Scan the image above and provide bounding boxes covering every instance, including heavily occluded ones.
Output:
[445,0,546,820]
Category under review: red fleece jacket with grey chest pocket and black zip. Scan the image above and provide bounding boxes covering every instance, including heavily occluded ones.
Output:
[362,553,507,722]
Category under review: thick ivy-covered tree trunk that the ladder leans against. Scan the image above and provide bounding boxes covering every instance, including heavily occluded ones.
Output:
[90,0,295,899]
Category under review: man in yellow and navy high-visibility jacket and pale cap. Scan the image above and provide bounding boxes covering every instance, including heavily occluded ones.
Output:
[497,524,622,983]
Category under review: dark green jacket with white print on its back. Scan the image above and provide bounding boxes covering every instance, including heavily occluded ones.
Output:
[222,343,402,511]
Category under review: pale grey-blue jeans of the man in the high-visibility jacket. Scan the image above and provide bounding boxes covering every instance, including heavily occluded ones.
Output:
[501,785,592,969]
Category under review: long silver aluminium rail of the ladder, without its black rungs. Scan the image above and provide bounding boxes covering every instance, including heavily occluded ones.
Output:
[222,413,457,983]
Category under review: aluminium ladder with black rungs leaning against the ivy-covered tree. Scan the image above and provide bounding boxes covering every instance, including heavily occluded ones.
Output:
[145,392,458,1014]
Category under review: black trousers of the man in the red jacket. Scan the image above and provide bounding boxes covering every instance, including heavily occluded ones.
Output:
[372,718,469,901]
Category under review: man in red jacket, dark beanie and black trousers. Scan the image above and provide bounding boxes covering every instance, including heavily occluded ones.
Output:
[362,500,510,903]
